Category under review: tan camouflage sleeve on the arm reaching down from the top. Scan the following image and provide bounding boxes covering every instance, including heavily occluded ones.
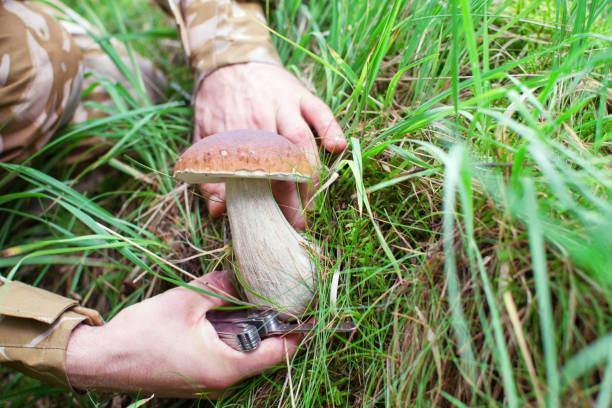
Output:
[157,0,281,89]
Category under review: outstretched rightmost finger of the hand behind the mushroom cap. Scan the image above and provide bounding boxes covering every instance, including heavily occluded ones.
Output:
[300,94,347,153]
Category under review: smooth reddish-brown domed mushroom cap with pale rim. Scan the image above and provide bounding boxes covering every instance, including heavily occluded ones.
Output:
[174,130,312,184]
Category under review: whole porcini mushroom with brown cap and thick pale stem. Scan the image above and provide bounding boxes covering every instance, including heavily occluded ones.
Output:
[174,130,315,317]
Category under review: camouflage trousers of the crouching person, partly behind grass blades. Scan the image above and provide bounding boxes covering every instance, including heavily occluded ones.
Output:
[0,0,166,163]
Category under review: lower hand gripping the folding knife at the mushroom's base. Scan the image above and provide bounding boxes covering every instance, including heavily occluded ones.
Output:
[66,271,298,398]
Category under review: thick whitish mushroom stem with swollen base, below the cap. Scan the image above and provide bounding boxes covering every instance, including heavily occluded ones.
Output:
[225,179,315,315]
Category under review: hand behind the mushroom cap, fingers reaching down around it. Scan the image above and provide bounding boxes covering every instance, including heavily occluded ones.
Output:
[194,62,346,229]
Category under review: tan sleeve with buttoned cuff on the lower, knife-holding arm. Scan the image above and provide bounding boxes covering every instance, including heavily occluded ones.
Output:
[0,281,104,388]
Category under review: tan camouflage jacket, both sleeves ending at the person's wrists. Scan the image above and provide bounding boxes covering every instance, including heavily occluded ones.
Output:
[0,0,280,388]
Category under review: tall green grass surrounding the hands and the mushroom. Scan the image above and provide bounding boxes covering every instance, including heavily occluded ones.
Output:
[0,0,612,407]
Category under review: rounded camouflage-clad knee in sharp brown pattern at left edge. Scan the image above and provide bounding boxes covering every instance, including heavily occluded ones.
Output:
[0,0,83,162]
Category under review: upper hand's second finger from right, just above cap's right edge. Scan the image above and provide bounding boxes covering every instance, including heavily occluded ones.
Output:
[276,106,319,171]
